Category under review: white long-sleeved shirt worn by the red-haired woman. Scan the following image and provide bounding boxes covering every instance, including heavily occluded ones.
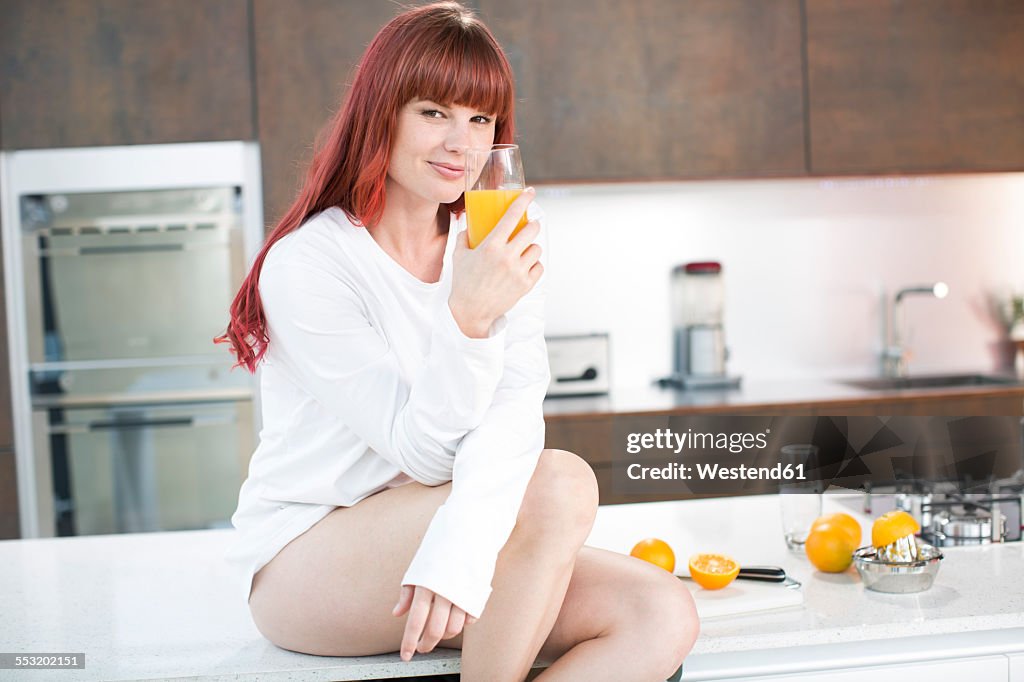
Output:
[221,202,550,616]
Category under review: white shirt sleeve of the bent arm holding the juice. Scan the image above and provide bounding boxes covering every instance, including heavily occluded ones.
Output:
[259,256,505,485]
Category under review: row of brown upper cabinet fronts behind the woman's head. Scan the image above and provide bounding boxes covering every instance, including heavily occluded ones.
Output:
[0,0,1024,183]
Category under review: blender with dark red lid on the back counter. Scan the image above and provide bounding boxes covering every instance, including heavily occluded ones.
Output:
[667,261,739,388]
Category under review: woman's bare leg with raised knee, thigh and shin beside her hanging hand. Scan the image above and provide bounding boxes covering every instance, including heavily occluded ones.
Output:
[244,451,597,659]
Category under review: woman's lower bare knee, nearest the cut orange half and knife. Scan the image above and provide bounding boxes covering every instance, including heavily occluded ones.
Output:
[623,571,700,679]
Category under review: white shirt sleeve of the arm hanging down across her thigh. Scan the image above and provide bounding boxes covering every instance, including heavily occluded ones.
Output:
[401,216,551,617]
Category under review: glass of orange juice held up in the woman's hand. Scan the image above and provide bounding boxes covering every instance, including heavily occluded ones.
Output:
[466,144,526,249]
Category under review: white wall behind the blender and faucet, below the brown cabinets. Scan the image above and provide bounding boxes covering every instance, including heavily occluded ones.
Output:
[538,173,1024,387]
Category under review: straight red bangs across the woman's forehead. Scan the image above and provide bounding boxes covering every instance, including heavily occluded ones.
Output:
[399,24,515,120]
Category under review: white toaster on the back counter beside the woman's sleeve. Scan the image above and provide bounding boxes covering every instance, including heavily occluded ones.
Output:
[546,334,609,396]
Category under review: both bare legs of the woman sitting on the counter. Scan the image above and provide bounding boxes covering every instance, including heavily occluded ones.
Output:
[250,451,697,682]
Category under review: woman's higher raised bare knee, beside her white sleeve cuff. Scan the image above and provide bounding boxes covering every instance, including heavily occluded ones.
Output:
[517,450,598,543]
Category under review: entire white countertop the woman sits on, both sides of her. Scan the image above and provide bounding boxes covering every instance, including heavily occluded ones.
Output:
[0,496,1024,682]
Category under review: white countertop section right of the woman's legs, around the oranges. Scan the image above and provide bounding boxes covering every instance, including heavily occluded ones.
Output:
[587,494,1024,680]
